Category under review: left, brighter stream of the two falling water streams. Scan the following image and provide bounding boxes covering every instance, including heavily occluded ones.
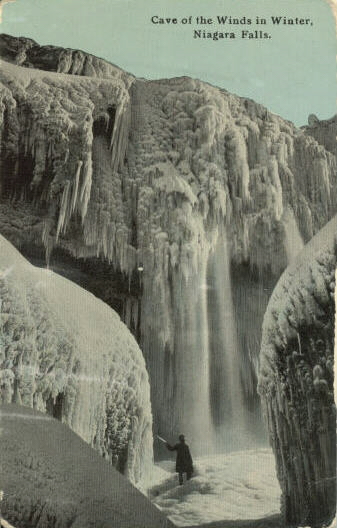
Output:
[174,256,214,453]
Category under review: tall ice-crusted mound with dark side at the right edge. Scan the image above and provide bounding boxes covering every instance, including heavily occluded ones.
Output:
[259,217,337,527]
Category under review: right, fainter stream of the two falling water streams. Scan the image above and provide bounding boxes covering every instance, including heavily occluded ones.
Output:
[208,230,246,449]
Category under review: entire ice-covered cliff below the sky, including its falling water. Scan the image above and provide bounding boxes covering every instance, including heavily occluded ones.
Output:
[0,36,337,450]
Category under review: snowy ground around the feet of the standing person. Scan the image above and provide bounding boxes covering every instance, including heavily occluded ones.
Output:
[143,449,281,526]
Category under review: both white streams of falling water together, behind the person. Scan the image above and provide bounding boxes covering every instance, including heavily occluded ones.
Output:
[159,228,250,454]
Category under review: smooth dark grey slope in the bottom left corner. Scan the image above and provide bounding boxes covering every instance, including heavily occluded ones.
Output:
[0,405,172,528]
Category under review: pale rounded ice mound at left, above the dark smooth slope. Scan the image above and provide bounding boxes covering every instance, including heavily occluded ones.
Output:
[0,235,152,482]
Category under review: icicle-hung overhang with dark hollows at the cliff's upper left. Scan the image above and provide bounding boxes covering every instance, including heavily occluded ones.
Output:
[1,58,130,268]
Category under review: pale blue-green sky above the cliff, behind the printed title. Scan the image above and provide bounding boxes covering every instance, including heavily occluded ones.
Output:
[1,0,337,125]
